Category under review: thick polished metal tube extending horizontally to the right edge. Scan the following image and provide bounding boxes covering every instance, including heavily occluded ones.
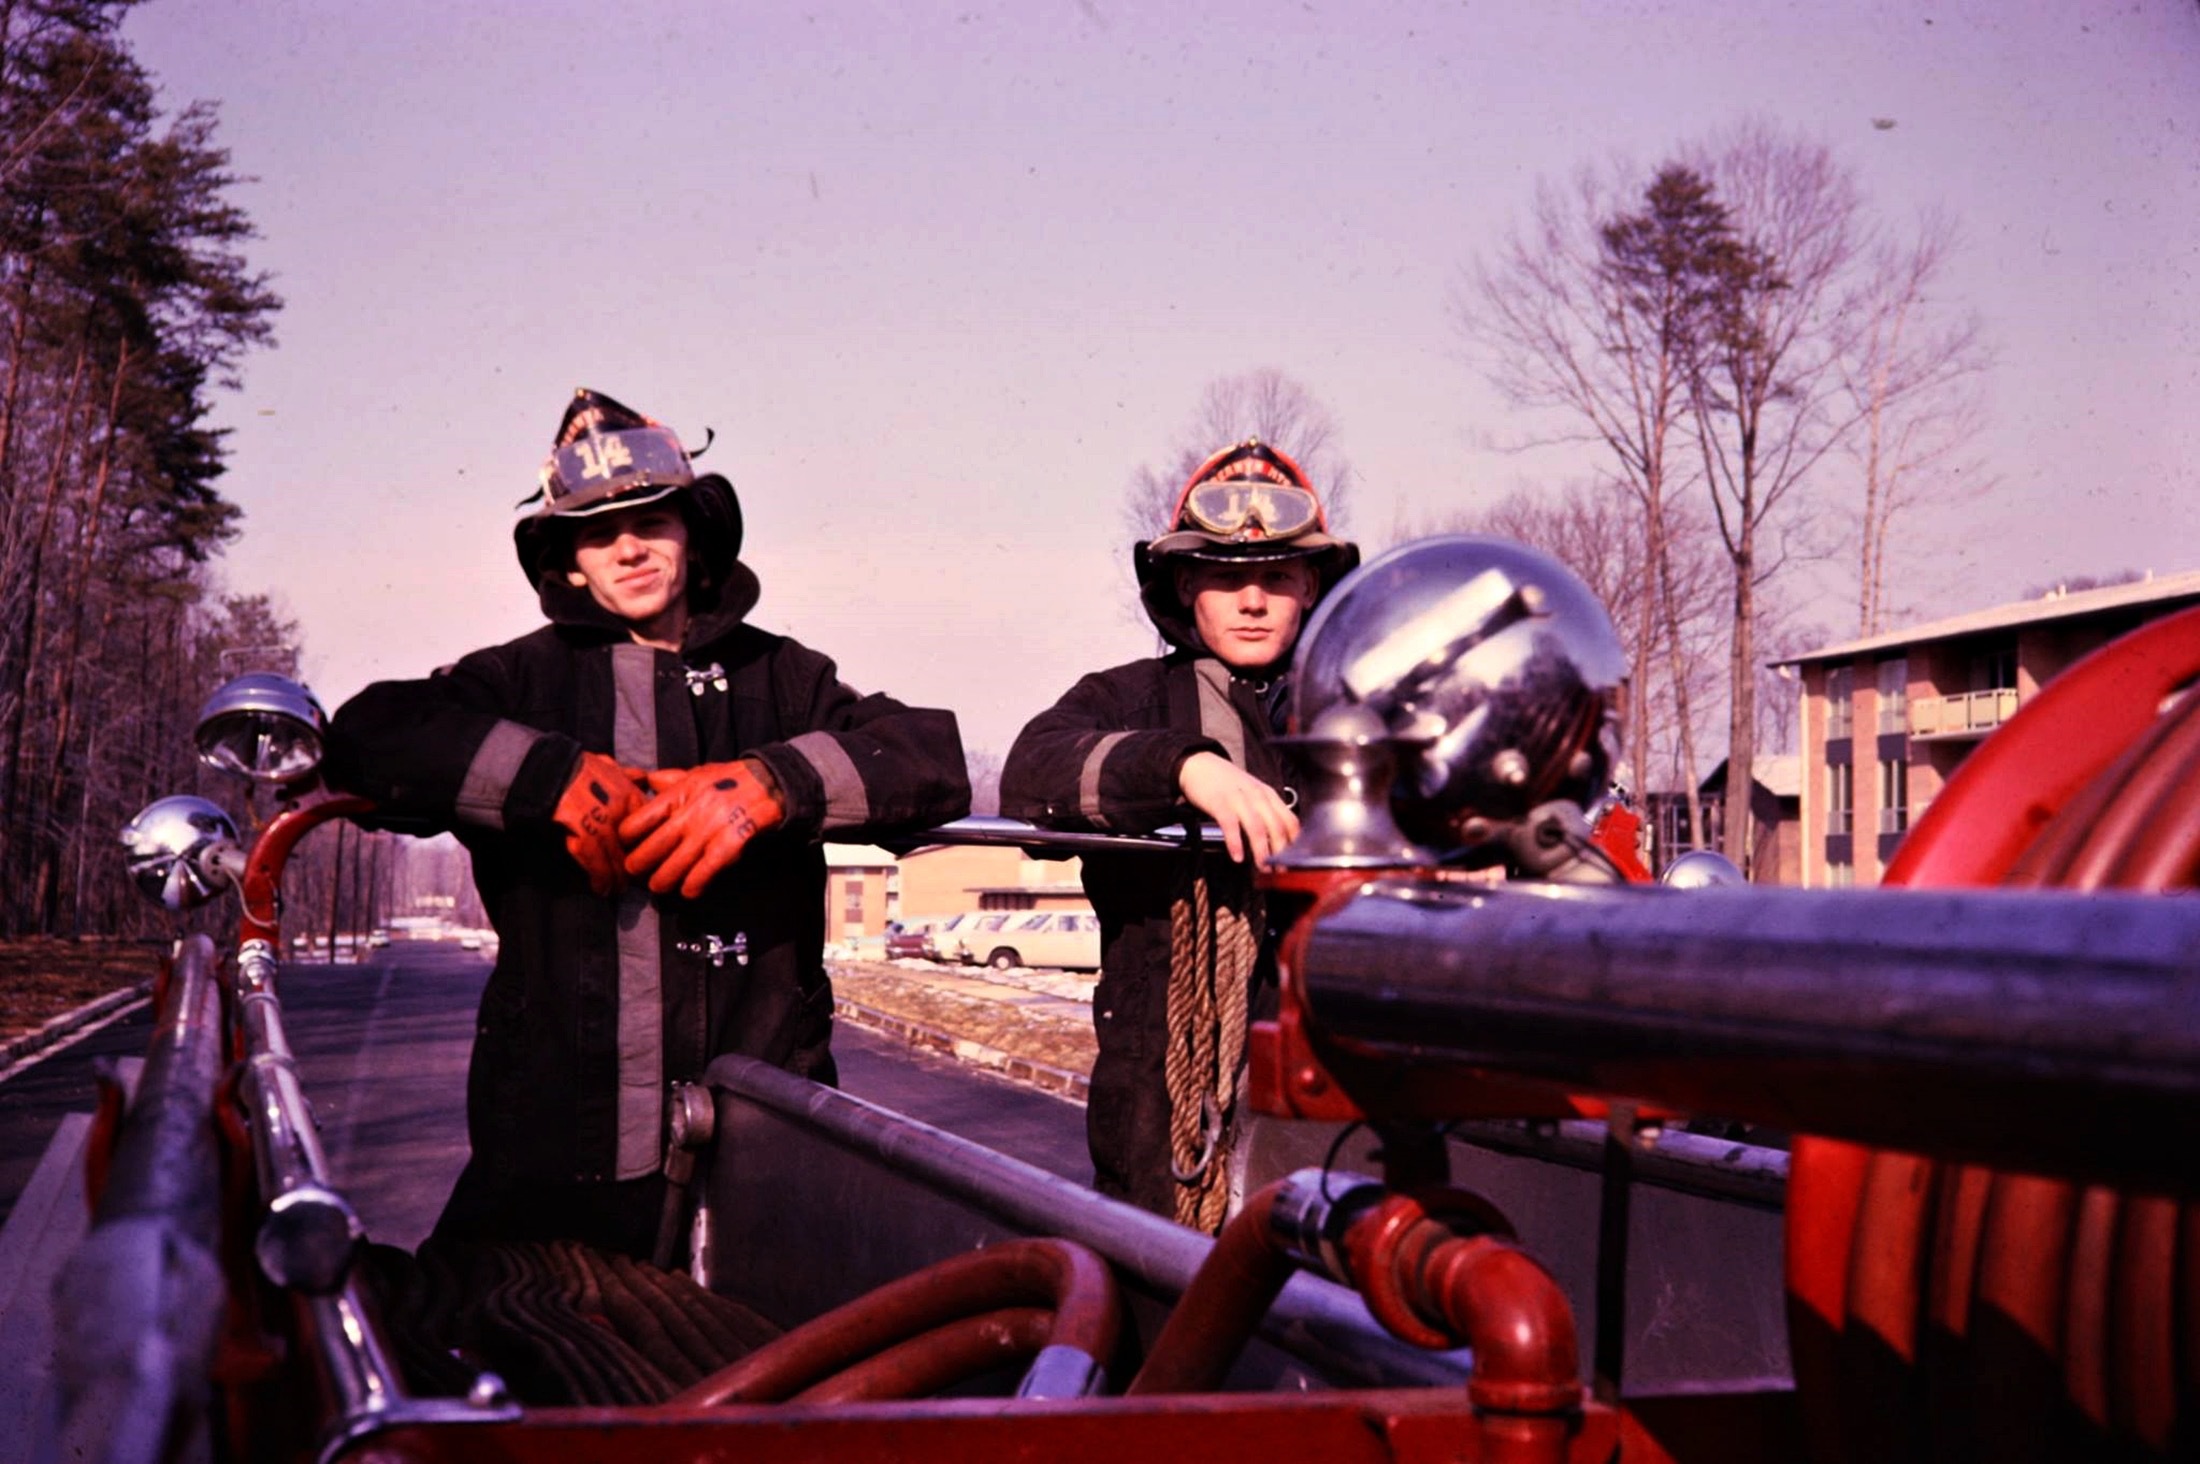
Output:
[1296,878,2200,1193]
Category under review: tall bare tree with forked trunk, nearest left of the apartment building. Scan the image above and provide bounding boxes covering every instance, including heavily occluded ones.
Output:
[1690,121,1866,867]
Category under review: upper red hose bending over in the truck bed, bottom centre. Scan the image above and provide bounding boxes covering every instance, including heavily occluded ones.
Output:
[662,1239,1122,1411]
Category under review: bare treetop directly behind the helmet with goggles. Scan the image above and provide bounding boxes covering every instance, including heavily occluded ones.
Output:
[1122,365,1353,539]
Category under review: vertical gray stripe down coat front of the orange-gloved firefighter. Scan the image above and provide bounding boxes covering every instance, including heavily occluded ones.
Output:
[612,645,664,1180]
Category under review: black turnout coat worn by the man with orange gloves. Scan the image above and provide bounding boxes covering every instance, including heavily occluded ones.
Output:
[328,550,970,1244]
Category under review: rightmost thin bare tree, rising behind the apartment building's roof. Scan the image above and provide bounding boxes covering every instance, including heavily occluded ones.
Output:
[1841,214,1991,636]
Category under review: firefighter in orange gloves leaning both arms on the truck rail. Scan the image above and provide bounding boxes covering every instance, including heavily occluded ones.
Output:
[328,390,970,1257]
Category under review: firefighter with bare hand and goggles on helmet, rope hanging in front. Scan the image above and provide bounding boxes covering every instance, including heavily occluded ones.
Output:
[1001,440,1360,1228]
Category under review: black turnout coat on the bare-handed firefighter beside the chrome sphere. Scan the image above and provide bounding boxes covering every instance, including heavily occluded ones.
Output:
[1001,647,1287,1215]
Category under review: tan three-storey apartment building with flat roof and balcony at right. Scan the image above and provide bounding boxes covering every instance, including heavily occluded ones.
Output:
[1773,570,2200,887]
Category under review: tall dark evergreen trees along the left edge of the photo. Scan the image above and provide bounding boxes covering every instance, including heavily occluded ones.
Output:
[0,0,283,936]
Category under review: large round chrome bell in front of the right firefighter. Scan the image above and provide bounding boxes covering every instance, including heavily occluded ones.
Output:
[1291,535,1628,850]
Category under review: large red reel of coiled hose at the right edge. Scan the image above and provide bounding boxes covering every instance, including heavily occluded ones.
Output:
[1789,610,2200,1460]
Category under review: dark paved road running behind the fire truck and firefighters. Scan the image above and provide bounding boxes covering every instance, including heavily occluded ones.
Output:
[0,942,1091,1246]
